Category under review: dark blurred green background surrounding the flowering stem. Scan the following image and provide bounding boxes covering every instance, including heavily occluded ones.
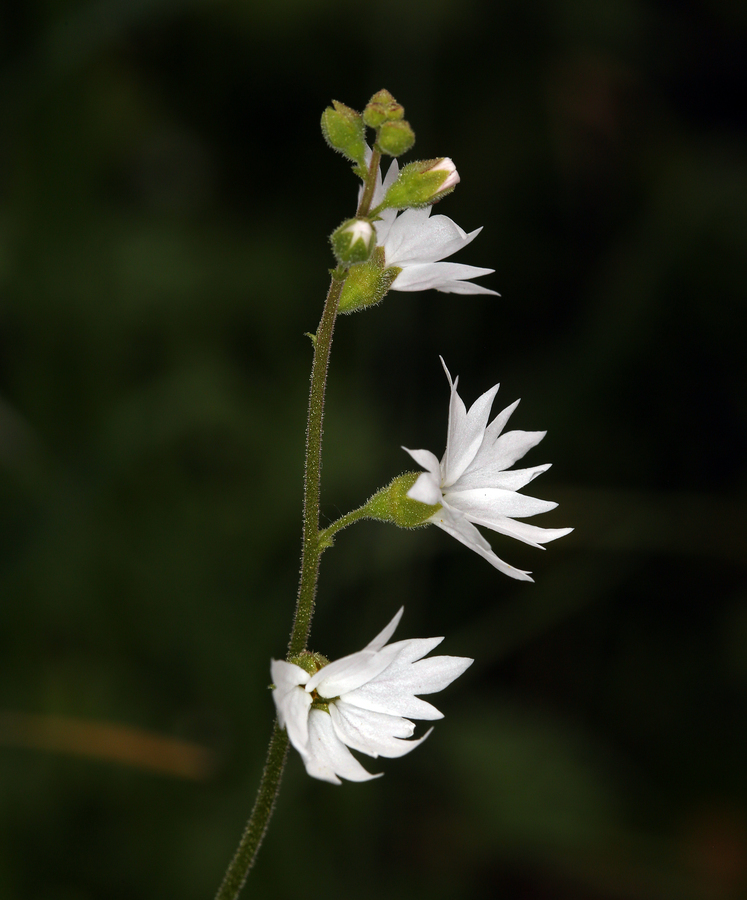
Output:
[0,0,747,900]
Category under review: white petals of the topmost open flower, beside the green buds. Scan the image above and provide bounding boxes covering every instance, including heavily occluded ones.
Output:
[371,159,499,296]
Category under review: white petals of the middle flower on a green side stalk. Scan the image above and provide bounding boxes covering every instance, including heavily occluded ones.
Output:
[403,359,573,581]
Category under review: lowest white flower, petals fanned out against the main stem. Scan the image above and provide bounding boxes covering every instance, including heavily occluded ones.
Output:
[271,609,472,784]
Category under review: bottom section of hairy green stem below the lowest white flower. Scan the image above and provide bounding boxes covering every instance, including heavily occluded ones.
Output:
[215,722,288,900]
